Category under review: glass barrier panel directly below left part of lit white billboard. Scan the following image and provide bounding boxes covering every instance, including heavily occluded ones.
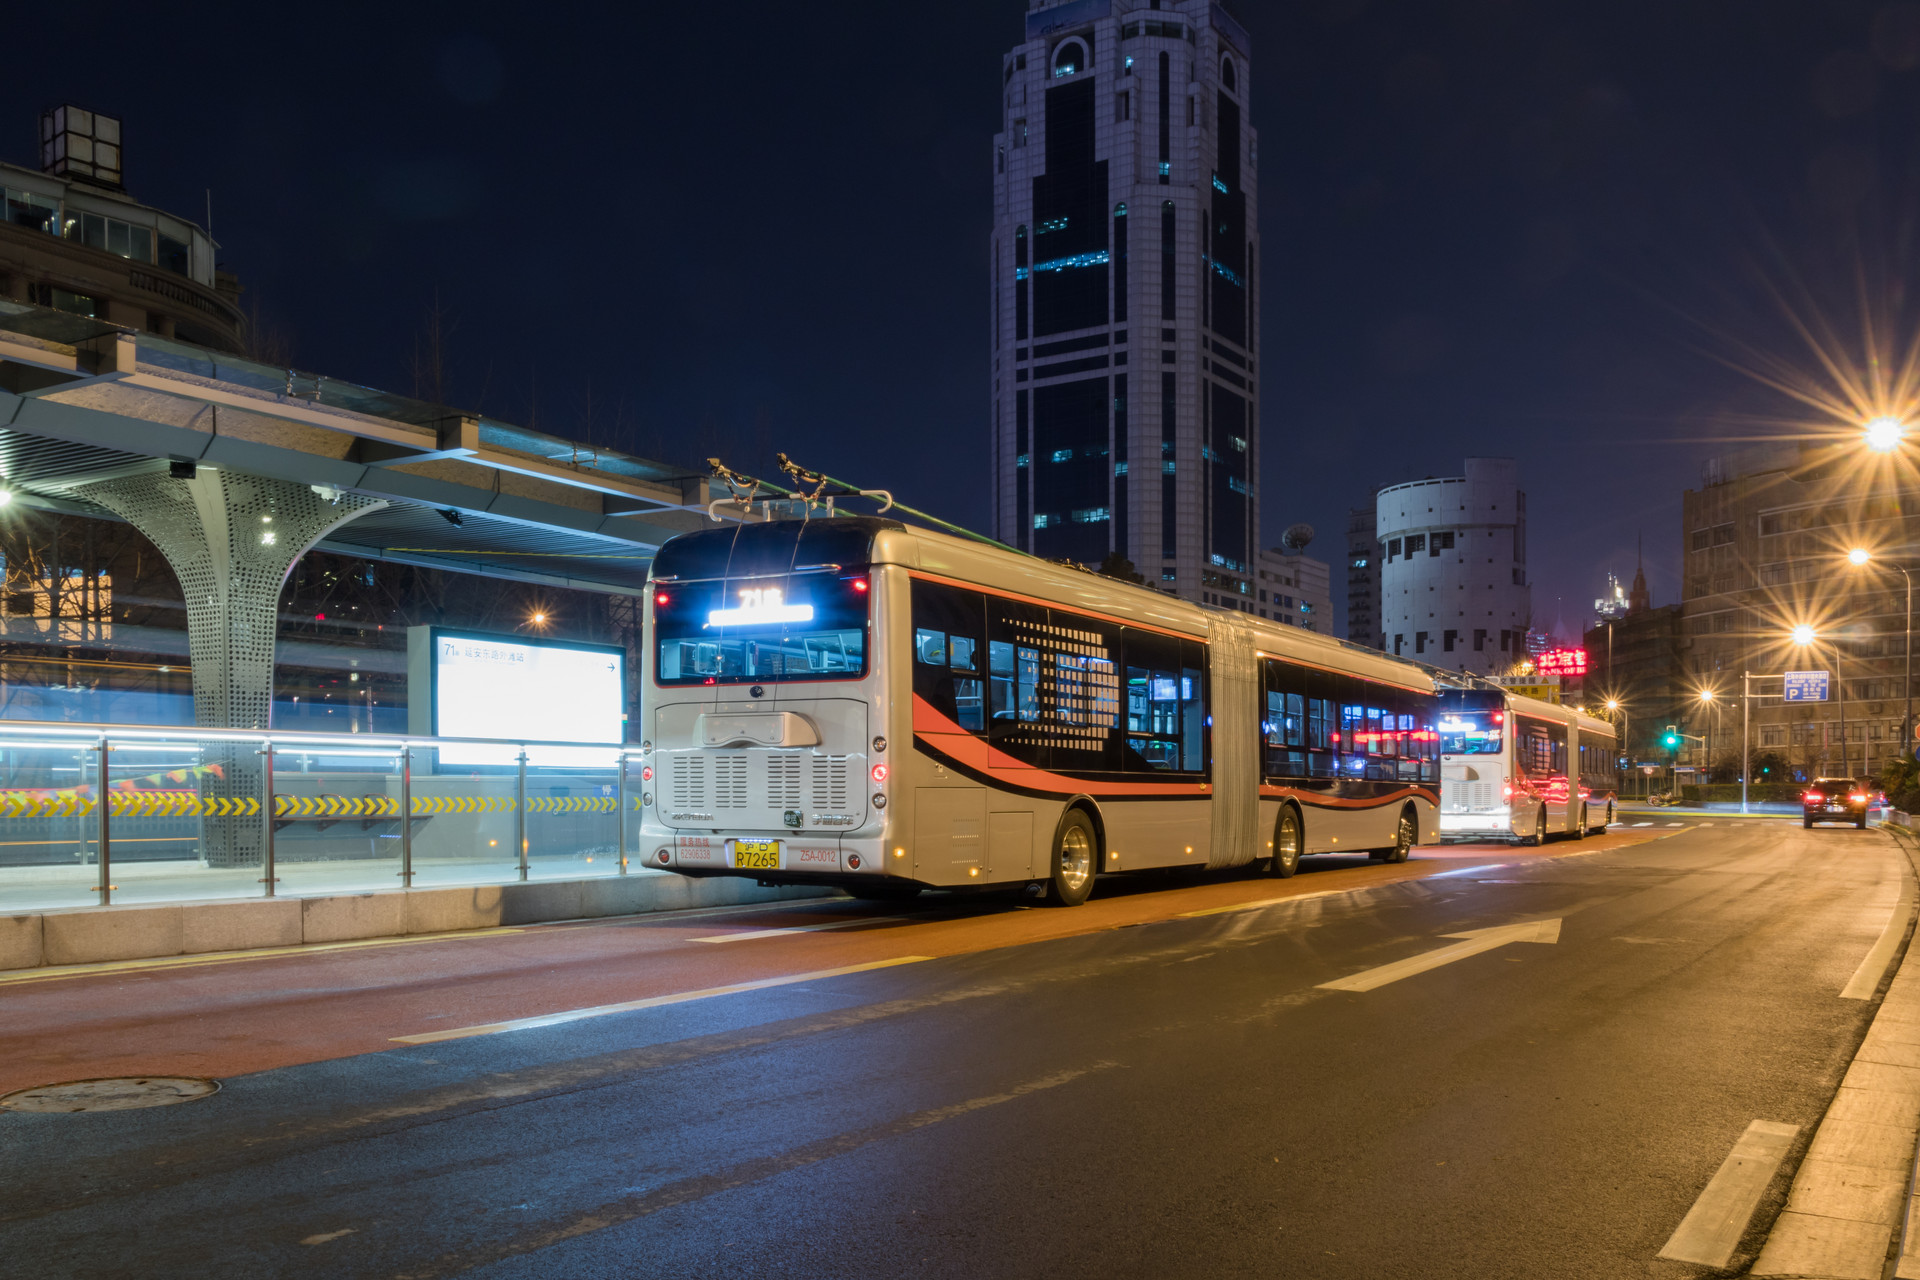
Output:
[408,747,520,887]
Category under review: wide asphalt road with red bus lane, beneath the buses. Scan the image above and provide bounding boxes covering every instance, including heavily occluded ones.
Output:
[0,819,1905,1280]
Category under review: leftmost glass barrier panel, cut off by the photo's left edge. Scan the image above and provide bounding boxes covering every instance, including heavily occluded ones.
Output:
[0,737,100,913]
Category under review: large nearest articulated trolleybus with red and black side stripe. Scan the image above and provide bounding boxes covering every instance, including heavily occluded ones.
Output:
[641,516,1440,906]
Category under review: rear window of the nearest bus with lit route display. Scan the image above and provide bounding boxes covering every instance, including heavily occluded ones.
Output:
[653,572,868,685]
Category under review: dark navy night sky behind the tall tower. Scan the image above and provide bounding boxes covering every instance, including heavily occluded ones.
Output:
[15,0,1920,626]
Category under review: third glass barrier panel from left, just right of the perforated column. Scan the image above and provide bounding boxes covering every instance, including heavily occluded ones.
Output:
[273,741,401,898]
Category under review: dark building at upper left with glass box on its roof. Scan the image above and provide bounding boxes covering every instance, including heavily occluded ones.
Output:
[0,106,244,351]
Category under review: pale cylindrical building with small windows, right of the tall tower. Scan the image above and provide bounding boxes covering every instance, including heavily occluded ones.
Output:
[1375,459,1532,676]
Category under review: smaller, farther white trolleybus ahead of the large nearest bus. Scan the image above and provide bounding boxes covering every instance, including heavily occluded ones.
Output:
[1440,689,1620,844]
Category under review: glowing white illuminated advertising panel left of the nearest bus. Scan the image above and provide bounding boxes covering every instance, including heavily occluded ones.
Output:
[432,628,626,768]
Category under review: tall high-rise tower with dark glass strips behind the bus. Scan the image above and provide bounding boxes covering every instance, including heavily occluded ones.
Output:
[991,0,1260,610]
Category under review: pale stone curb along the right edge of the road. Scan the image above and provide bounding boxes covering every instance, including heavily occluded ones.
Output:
[1749,827,1920,1280]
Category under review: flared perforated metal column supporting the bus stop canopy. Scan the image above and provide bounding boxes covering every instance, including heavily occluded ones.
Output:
[77,466,386,867]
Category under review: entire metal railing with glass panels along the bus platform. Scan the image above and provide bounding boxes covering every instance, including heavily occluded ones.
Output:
[0,722,645,913]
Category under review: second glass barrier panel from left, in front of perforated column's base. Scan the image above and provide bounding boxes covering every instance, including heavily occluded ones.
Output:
[104,729,267,906]
